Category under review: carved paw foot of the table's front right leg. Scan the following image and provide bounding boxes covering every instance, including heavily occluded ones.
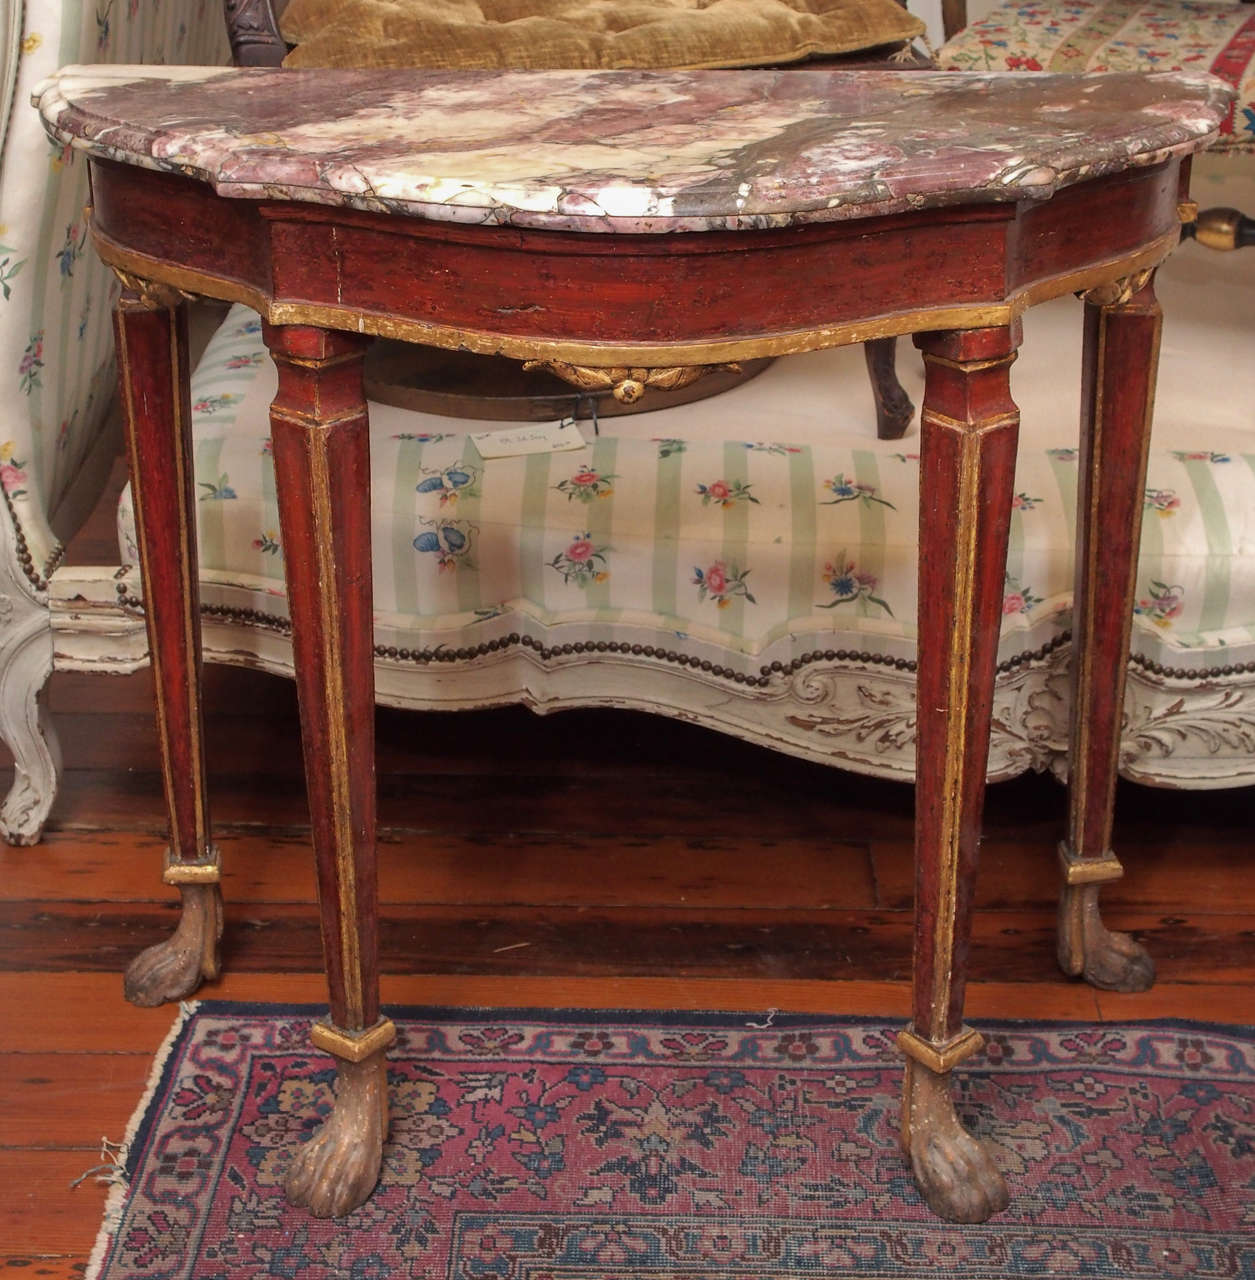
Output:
[902,1061,1010,1222]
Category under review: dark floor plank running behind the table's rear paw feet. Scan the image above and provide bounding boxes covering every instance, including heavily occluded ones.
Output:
[7,902,1255,982]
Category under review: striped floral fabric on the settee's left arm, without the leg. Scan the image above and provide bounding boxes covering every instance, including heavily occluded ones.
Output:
[0,0,228,576]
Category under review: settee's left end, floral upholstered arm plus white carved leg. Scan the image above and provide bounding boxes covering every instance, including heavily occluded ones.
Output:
[0,0,227,844]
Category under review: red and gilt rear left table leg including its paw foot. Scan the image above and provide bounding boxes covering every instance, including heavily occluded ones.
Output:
[114,279,223,1005]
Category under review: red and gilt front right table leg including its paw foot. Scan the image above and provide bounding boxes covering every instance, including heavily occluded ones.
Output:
[899,326,1019,1222]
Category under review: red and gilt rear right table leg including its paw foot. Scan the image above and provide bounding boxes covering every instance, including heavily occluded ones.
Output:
[1059,276,1162,991]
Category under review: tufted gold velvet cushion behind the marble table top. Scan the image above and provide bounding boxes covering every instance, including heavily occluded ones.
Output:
[276,0,923,70]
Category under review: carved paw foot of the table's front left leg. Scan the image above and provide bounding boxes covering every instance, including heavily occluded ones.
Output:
[284,1052,388,1217]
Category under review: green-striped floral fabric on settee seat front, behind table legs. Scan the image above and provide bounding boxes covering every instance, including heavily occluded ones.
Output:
[119,301,1255,672]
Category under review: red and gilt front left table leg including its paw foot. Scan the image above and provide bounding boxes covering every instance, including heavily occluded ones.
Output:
[265,325,396,1217]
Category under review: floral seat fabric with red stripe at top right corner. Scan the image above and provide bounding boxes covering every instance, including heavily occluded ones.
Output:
[937,0,1255,151]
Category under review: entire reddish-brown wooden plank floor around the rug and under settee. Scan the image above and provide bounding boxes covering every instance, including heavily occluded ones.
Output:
[0,458,1255,1276]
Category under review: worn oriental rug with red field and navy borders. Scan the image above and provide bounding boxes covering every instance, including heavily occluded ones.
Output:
[88,1002,1255,1280]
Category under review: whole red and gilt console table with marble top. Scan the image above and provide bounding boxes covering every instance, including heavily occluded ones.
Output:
[36,67,1227,1221]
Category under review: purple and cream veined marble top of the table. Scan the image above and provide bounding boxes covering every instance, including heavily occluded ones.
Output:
[35,65,1231,233]
